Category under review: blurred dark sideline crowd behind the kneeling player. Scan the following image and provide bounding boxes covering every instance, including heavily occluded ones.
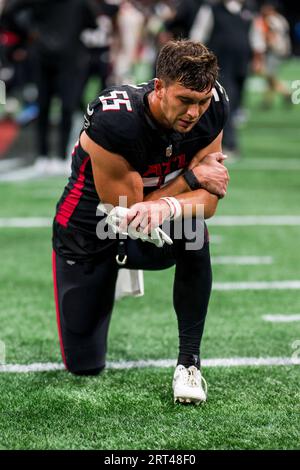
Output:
[0,0,300,173]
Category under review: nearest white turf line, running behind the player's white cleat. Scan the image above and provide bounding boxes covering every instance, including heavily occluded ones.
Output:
[0,357,300,373]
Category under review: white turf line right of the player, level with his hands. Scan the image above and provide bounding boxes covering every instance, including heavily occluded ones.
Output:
[207,215,300,226]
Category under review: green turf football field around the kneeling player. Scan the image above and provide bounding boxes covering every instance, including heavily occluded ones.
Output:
[0,61,300,450]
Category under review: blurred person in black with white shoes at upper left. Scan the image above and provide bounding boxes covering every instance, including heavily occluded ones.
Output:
[3,0,96,173]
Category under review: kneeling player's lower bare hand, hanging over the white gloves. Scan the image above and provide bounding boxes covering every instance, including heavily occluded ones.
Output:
[120,200,171,235]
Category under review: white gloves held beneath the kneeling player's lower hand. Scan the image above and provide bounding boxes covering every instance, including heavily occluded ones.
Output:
[104,205,173,248]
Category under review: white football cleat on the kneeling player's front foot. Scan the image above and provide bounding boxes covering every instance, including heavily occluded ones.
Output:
[173,364,207,405]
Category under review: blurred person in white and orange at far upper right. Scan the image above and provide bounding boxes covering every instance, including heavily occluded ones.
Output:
[251,0,292,109]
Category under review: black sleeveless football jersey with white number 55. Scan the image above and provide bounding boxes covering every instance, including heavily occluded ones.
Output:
[53,80,228,260]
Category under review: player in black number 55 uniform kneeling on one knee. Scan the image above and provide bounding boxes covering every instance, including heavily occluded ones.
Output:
[53,41,228,403]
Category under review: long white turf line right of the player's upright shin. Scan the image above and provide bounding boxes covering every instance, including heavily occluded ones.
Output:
[213,281,300,291]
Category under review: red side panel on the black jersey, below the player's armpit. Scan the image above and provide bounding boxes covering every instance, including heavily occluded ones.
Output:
[55,155,90,228]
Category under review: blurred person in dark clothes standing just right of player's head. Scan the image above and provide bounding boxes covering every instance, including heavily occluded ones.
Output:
[190,0,254,159]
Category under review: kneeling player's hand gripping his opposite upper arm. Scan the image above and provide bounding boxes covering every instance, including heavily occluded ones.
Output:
[189,152,229,198]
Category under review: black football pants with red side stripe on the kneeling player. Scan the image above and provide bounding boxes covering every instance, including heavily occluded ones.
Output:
[53,229,212,373]
